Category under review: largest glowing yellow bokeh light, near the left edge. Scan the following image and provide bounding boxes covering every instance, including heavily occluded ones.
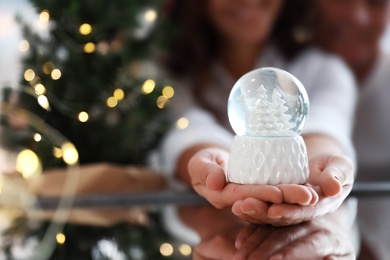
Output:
[16,149,42,179]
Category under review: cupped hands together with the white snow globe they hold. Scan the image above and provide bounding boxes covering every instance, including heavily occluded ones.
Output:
[186,68,354,226]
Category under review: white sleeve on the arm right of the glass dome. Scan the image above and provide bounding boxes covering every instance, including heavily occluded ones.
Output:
[293,51,357,160]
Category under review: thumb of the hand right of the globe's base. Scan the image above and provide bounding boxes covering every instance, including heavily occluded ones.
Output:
[319,156,354,196]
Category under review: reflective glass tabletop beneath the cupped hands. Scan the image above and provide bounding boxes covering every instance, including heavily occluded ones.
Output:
[1,182,390,259]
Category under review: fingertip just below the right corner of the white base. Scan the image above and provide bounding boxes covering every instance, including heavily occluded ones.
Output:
[277,184,316,205]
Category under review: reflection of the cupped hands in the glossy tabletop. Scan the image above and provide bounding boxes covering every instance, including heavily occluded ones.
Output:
[233,217,355,260]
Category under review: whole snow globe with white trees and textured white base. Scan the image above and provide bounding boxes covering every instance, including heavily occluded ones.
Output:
[227,68,309,185]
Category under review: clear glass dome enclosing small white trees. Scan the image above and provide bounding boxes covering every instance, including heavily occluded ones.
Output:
[228,67,309,137]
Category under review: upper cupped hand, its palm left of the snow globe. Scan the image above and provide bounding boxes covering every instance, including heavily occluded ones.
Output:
[188,148,317,211]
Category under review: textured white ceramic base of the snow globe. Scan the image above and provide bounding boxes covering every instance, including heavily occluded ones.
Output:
[226,136,309,185]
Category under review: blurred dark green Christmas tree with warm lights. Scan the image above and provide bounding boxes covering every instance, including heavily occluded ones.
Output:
[18,0,174,164]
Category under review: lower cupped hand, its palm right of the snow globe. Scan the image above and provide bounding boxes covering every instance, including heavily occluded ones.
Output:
[232,155,354,226]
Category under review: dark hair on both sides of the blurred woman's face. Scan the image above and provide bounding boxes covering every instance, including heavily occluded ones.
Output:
[164,0,312,79]
